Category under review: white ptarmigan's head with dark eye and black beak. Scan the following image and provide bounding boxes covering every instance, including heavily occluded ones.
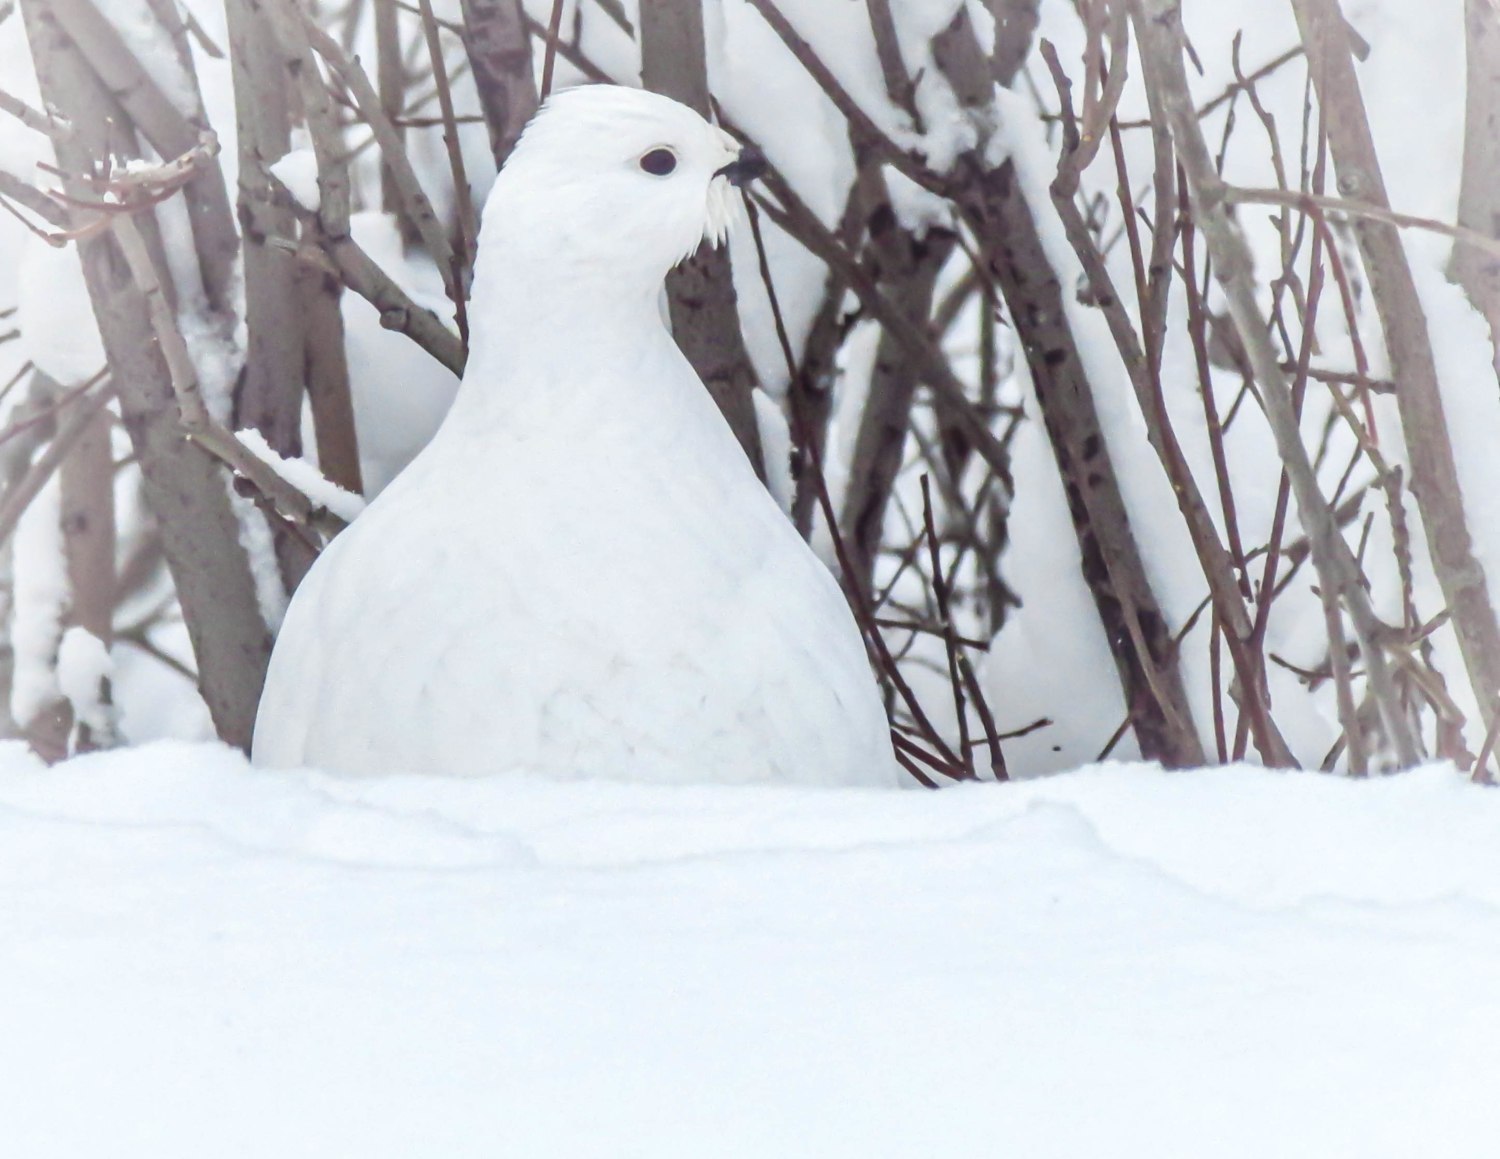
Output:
[482,85,765,285]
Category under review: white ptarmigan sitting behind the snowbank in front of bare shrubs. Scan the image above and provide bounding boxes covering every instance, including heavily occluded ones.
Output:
[254,85,900,786]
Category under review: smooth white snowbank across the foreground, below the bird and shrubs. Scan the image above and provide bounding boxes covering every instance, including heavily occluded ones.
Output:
[0,744,1500,1159]
